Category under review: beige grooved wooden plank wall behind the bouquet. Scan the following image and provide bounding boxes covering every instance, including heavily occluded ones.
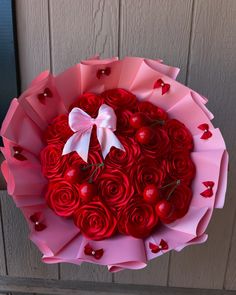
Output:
[0,0,236,294]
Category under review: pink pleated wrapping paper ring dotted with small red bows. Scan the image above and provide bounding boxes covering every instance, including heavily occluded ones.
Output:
[1,57,228,272]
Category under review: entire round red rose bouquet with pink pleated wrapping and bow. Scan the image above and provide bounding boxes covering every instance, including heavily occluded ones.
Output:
[1,57,228,272]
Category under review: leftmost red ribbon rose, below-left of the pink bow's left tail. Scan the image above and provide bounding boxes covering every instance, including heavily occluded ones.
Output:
[40,144,67,179]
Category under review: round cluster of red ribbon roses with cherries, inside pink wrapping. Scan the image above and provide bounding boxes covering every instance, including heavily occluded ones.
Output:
[41,88,195,240]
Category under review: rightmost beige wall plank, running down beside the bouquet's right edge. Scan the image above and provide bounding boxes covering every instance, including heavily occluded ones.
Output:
[169,0,236,289]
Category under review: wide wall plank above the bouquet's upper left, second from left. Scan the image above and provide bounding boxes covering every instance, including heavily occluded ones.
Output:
[50,0,119,73]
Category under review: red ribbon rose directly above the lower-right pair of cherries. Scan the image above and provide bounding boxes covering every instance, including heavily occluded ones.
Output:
[131,157,166,195]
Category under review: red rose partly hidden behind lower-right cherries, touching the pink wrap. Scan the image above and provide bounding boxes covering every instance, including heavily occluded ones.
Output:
[161,183,192,223]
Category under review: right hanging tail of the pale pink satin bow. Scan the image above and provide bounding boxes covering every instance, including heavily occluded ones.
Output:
[97,127,125,159]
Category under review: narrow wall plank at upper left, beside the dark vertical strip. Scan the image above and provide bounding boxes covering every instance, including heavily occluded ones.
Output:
[15,0,50,90]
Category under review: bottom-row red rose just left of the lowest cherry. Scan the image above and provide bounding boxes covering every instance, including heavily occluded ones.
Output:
[118,201,158,239]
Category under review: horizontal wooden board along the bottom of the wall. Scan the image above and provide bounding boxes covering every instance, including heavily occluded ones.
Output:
[0,277,235,295]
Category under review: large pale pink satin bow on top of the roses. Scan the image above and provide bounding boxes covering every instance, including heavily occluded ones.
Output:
[62,104,125,162]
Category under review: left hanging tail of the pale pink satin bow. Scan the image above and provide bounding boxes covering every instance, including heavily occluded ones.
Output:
[62,127,92,163]
